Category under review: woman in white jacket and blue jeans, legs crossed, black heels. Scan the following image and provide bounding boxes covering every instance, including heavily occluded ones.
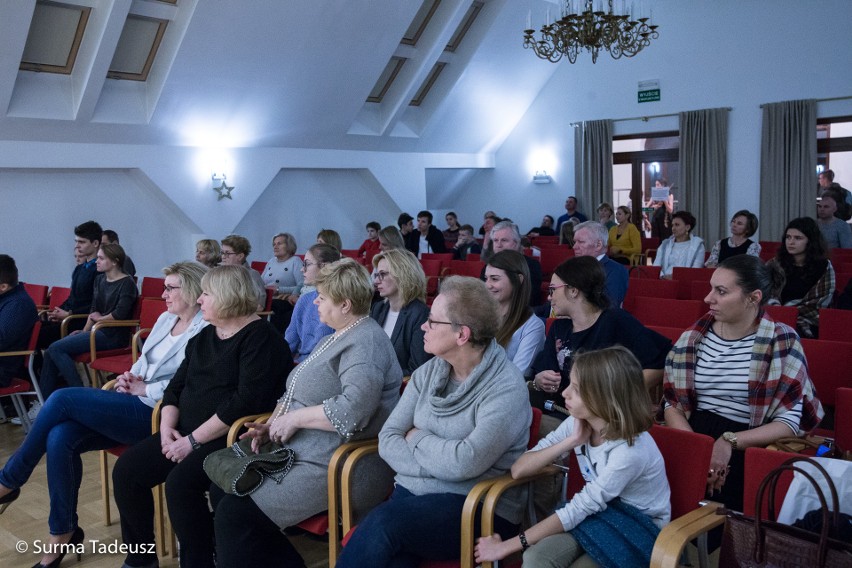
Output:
[0,262,207,566]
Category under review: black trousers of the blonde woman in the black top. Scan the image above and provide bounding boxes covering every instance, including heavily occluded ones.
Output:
[112,434,226,568]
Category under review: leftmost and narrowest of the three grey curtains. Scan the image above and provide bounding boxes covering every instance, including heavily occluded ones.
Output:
[574,120,612,217]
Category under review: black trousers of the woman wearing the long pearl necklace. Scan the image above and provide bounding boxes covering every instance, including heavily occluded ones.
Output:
[210,481,305,568]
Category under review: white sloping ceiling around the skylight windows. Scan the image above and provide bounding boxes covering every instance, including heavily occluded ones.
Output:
[0,0,557,152]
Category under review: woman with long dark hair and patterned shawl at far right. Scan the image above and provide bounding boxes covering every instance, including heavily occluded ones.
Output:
[770,217,835,337]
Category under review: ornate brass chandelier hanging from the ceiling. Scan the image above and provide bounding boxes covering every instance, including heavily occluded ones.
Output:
[524,0,660,63]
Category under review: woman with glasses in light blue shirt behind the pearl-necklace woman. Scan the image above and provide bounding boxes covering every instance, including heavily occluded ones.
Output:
[284,244,340,363]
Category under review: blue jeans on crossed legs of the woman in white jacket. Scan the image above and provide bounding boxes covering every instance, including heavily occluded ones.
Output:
[0,387,153,534]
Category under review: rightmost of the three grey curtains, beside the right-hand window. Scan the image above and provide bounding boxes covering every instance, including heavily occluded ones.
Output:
[760,100,817,241]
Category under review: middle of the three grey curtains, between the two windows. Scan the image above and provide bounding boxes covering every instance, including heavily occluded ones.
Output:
[678,108,728,246]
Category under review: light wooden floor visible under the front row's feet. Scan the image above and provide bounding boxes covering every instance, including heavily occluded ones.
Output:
[0,423,328,568]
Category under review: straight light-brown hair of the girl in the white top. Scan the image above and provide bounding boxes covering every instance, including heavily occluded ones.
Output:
[571,345,653,446]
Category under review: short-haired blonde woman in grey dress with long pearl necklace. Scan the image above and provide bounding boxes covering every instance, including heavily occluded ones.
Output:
[210,258,402,566]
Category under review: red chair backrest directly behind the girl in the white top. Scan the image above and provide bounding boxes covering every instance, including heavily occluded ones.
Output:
[650,425,715,519]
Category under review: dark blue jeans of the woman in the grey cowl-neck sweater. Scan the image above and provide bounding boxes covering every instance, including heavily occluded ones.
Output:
[337,485,517,568]
